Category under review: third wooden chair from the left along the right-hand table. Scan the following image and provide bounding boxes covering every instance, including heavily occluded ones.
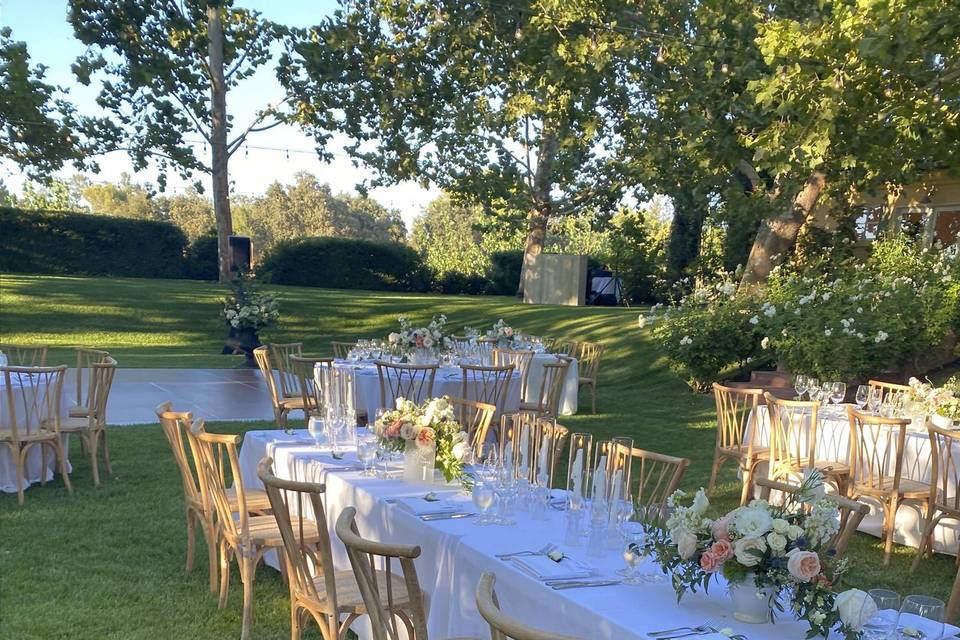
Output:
[847,407,931,565]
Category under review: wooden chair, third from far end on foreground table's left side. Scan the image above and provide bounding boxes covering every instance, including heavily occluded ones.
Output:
[257,457,390,640]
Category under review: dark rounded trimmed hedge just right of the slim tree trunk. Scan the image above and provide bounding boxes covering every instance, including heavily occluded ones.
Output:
[257,238,430,291]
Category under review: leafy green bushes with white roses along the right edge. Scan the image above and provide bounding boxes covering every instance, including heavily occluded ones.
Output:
[652,239,960,390]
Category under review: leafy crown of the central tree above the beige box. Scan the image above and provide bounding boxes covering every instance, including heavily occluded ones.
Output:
[281,0,629,296]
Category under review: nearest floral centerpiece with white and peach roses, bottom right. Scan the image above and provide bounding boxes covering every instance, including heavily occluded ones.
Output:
[644,471,876,640]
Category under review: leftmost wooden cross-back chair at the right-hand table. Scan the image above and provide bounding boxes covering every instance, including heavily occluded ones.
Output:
[707,383,770,506]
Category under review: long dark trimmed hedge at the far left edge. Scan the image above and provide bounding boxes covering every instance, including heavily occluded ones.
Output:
[0,207,188,278]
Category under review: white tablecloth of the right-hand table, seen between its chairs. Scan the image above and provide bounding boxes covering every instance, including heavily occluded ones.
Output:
[755,406,960,555]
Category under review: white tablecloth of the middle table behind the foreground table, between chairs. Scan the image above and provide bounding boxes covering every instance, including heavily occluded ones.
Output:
[318,353,580,417]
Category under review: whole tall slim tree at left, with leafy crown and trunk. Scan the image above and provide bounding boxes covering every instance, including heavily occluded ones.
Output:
[69,0,285,280]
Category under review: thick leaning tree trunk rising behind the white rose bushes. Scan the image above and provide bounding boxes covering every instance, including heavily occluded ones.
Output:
[740,171,825,287]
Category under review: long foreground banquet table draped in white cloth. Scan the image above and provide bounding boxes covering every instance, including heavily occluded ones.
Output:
[240,431,924,640]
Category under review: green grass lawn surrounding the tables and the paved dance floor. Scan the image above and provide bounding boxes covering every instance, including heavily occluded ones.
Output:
[0,275,955,640]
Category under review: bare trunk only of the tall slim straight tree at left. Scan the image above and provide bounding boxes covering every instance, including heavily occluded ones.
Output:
[207,3,233,282]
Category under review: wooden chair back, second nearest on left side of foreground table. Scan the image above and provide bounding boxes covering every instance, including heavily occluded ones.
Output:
[336,507,427,640]
